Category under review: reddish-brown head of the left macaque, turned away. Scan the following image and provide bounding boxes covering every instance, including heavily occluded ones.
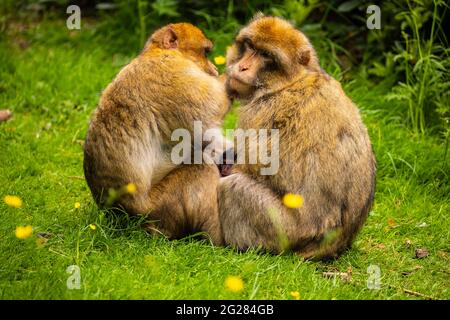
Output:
[148,23,219,77]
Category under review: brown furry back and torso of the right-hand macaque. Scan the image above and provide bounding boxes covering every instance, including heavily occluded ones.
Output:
[237,74,376,256]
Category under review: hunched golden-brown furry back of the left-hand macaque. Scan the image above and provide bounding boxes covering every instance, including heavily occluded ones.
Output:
[84,52,227,210]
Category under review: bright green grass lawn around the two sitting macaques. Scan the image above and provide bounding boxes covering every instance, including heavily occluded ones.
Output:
[0,16,450,299]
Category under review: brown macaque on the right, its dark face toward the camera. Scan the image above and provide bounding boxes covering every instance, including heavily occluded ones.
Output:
[218,15,376,259]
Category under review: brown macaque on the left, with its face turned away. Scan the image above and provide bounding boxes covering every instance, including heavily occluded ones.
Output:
[84,23,230,244]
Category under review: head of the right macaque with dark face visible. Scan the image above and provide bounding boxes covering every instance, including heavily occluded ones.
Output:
[226,16,318,100]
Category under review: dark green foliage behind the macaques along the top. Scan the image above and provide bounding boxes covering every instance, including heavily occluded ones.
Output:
[0,0,450,136]
